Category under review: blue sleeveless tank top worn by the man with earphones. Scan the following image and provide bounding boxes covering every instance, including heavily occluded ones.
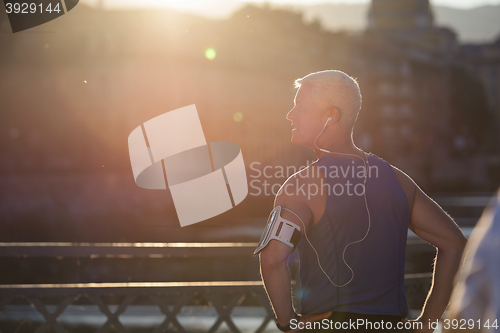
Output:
[297,154,409,317]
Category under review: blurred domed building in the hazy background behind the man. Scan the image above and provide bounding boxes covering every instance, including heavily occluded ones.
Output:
[338,0,499,190]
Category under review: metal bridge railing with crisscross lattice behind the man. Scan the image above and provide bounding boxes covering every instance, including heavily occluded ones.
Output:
[0,243,431,333]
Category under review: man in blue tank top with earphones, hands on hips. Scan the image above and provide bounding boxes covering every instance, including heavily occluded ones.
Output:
[256,70,466,332]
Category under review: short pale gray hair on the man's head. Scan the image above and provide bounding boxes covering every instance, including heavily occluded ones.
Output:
[295,70,362,129]
